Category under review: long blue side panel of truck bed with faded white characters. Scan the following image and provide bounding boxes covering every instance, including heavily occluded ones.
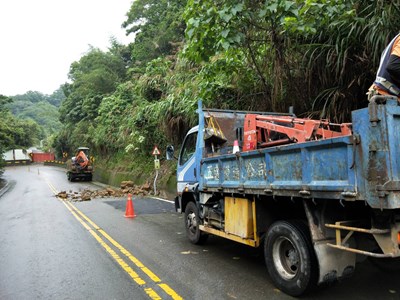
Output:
[201,137,356,199]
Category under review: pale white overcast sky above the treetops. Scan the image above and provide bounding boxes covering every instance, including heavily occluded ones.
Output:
[0,0,133,96]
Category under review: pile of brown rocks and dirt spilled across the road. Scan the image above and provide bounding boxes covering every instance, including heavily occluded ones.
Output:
[56,181,151,201]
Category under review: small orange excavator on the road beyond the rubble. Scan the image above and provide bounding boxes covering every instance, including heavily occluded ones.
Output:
[67,147,93,181]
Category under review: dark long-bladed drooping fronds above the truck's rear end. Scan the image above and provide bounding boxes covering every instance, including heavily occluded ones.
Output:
[303,0,400,121]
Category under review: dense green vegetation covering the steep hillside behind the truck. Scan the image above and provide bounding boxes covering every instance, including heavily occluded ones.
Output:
[2,0,400,180]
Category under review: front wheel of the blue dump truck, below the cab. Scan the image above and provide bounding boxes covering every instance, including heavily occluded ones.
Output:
[185,202,208,245]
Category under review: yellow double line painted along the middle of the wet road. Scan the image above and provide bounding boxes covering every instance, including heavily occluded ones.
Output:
[47,181,182,300]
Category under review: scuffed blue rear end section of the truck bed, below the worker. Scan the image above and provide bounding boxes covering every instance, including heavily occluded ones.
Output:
[352,100,400,209]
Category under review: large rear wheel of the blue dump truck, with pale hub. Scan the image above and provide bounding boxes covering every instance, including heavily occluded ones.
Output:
[264,221,318,296]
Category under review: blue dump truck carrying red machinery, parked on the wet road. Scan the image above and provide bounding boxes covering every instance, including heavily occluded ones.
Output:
[167,96,400,296]
